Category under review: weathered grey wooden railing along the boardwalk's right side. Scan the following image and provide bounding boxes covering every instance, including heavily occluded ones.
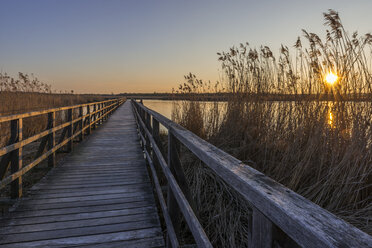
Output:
[132,100,372,248]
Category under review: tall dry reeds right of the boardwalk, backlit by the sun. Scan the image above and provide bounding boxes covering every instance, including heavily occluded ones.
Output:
[172,10,372,247]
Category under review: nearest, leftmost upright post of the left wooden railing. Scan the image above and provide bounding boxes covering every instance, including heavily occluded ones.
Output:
[10,118,23,199]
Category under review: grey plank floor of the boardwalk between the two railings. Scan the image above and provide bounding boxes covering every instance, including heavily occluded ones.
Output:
[0,101,164,247]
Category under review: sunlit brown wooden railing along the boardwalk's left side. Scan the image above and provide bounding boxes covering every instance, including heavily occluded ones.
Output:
[0,99,125,198]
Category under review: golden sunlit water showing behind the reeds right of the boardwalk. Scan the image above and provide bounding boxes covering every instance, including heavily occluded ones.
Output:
[143,100,372,139]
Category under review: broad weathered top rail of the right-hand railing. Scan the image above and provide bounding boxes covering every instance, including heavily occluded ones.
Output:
[134,100,372,248]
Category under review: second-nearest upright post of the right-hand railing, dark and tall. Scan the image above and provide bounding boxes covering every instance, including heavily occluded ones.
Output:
[167,129,181,247]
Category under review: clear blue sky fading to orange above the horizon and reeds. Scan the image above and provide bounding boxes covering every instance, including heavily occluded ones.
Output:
[0,0,372,93]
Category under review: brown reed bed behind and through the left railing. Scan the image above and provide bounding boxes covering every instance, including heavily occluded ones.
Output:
[0,73,110,200]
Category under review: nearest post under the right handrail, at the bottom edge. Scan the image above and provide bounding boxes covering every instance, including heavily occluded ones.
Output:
[250,208,273,248]
